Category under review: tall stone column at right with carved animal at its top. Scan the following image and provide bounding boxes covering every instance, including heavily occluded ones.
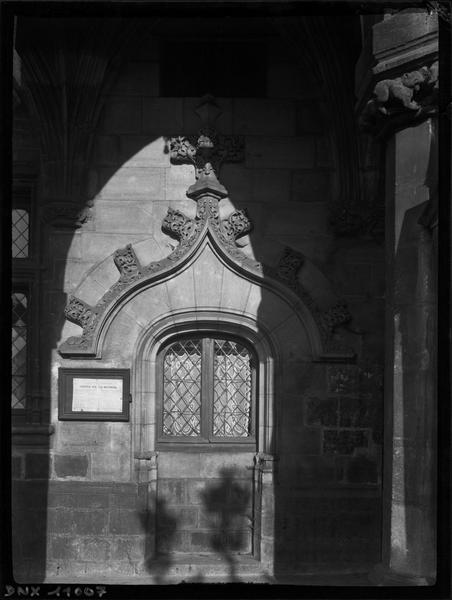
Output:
[357,11,438,585]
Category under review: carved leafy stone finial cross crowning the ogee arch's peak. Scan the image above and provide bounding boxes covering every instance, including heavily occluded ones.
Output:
[169,95,245,185]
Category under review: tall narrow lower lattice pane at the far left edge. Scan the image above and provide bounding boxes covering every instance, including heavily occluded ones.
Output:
[11,292,27,408]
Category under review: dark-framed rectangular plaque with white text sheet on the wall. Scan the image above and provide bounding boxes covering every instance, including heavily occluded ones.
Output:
[58,368,130,421]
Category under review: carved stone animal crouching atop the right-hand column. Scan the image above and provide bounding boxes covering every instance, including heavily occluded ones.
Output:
[374,67,430,115]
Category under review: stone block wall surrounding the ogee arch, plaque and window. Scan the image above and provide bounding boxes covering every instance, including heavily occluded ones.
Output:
[14,19,384,575]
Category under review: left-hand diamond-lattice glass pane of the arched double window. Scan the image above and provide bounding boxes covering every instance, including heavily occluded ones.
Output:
[163,340,201,437]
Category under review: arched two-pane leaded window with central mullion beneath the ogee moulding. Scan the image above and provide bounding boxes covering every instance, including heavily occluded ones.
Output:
[159,336,255,443]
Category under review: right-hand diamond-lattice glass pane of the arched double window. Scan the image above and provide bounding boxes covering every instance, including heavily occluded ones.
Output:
[213,340,251,437]
